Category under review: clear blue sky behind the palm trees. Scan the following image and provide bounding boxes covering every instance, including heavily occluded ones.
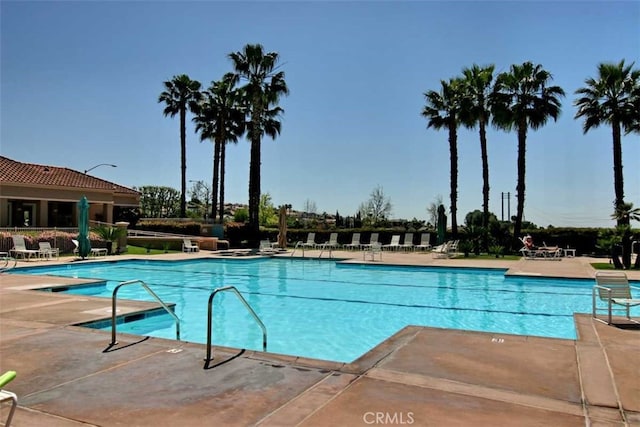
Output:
[0,1,640,226]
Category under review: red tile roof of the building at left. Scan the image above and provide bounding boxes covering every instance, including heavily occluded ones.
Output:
[0,156,139,194]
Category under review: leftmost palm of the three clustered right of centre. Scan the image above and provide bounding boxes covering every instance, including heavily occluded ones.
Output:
[422,78,463,239]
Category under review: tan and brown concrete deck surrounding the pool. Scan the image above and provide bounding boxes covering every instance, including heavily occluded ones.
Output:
[0,251,640,427]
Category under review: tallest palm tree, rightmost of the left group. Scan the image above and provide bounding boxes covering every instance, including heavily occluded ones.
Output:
[229,44,289,234]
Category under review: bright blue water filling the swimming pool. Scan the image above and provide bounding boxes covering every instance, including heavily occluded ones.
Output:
[19,259,637,362]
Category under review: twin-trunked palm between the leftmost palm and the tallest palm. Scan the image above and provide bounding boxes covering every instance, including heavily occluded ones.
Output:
[193,73,244,223]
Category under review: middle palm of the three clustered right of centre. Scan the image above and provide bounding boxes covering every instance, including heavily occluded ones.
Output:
[460,64,495,237]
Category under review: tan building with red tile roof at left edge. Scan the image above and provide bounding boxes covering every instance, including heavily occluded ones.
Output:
[0,156,140,227]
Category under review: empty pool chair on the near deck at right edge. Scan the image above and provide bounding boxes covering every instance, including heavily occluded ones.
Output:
[592,271,640,325]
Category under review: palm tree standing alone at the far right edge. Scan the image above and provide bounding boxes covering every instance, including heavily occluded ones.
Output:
[574,60,640,225]
